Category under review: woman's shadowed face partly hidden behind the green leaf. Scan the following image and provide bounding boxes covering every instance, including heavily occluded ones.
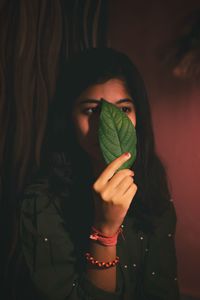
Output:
[72,79,136,161]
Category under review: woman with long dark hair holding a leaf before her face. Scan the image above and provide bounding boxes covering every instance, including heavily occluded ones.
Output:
[20,48,179,300]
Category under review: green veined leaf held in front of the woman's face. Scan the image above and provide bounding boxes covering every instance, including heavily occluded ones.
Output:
[99,99,137,170]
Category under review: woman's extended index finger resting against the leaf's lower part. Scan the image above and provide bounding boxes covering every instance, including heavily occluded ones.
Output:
[98,152,131,183]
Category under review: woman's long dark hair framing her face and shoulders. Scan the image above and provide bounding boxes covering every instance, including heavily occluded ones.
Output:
[44,48,170,231]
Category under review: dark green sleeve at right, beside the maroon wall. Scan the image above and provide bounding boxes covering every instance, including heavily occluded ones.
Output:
[143,202,180,300]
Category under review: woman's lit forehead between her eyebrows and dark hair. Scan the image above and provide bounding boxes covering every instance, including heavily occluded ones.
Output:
[76,79,131,103]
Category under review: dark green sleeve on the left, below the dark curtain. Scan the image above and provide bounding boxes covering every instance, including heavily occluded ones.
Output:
[20,180,121,300]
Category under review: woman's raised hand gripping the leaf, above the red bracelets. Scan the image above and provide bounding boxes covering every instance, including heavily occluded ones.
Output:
[92,153,137,236]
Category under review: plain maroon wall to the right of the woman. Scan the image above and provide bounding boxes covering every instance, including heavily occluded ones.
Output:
[109,0,200,298]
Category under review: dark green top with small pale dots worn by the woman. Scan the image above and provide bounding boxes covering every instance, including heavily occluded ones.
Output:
[20,173,179,300]
